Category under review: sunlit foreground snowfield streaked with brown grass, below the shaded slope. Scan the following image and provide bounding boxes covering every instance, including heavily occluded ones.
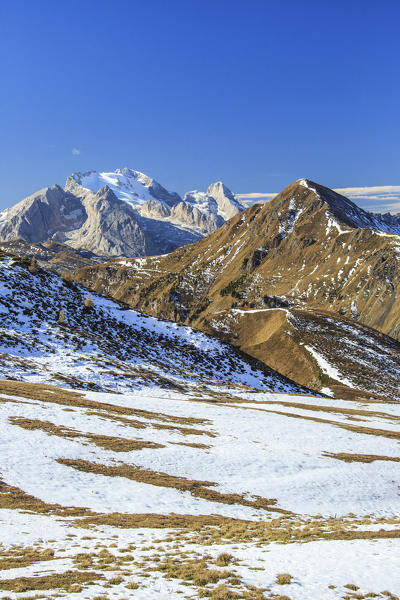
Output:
[0,381,400,600]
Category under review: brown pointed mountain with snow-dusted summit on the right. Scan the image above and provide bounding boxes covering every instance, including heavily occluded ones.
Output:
[73,180,400,398]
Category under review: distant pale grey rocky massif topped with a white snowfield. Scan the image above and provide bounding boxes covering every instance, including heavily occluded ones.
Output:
[0,169,244,257]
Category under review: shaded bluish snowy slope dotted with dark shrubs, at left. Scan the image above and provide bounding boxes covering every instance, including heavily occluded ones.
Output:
[0,258,301,392]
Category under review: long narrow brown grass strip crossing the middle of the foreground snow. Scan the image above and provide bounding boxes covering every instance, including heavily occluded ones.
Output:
[57,458,291,514]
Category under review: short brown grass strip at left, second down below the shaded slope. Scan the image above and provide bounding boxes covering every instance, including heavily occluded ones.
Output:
[9,417,165,452]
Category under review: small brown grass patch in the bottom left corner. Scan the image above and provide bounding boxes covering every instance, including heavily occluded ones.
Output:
[0,571,104,593]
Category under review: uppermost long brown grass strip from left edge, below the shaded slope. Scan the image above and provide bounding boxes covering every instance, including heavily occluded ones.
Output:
[0,380,215,437]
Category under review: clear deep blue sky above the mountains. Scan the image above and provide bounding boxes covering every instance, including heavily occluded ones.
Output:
[0,0,400,207]
